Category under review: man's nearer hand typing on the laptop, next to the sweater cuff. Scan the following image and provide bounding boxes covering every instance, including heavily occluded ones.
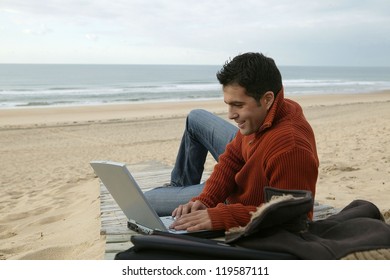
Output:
[170,209,212,231]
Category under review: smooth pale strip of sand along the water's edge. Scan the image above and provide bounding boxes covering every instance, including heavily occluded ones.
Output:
[0,89,390,128]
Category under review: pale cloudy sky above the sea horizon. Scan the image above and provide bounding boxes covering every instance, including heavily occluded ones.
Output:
[0,0,390,66]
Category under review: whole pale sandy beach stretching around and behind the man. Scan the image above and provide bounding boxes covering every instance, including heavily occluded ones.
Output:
[0,91,390,260]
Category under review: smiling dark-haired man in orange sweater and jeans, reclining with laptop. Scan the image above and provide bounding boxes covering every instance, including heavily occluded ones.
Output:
[146,53,319,231]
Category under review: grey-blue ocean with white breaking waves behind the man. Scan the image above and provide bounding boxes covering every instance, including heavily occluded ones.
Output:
[0,64,390,109]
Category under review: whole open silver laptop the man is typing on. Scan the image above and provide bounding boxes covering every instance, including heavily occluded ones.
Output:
[90,161,224,238]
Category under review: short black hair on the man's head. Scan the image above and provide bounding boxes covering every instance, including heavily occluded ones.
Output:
[217,52,282,101]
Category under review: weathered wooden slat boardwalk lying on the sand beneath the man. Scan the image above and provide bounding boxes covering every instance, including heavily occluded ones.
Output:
[100,163,338,260]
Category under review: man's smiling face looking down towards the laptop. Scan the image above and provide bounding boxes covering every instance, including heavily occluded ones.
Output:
[223,85,273,135]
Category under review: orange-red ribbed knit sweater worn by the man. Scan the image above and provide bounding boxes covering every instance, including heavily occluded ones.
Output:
[192,90,319,230]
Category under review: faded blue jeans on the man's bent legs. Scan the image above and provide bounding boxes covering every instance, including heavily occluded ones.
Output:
[145,109,238,216]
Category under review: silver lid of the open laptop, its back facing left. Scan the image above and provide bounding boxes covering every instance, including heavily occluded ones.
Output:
[90,161,167,231]
